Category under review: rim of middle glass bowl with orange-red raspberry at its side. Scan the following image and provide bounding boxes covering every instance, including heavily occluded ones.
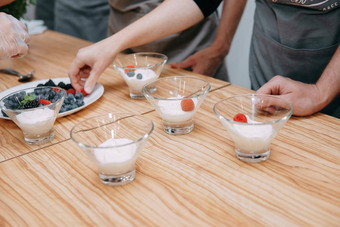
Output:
[142,76,211,101]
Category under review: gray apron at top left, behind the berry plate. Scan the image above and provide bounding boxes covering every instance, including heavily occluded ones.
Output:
[36,0,110,42]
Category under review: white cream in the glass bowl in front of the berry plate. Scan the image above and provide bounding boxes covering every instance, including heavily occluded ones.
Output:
[16,108,55,135]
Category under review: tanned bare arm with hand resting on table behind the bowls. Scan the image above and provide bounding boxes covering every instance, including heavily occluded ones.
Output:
[171,0,247,76]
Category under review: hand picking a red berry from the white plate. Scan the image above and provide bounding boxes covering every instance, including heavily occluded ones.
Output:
[68,39,115,94]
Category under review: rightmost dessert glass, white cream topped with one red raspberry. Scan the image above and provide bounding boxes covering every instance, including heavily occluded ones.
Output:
[213,94,293,162]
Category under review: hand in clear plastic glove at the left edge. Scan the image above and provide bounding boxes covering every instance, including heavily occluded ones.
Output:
[0,13,29,59]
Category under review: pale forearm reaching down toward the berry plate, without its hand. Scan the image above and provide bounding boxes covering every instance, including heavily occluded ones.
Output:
[108,0,203,58]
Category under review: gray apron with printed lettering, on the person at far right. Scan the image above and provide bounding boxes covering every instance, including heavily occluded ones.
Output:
[249,0,340,118]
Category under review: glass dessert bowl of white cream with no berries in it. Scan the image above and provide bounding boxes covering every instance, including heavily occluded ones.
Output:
[71,113,154,186]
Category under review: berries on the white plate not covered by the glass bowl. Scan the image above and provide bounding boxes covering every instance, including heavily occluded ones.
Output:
[37,80,85,113]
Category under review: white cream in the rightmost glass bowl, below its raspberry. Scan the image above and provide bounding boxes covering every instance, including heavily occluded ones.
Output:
[222,116,274,153]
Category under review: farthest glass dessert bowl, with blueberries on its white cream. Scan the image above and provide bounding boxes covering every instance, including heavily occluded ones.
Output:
[113,52,168,99]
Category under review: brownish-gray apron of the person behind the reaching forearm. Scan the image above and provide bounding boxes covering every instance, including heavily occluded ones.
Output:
[109,0,228,81]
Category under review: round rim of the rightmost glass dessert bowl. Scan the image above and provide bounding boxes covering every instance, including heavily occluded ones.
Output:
[213,93,294,125]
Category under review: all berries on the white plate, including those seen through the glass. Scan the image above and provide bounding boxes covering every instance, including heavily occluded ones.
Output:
[1,80,85,117]
